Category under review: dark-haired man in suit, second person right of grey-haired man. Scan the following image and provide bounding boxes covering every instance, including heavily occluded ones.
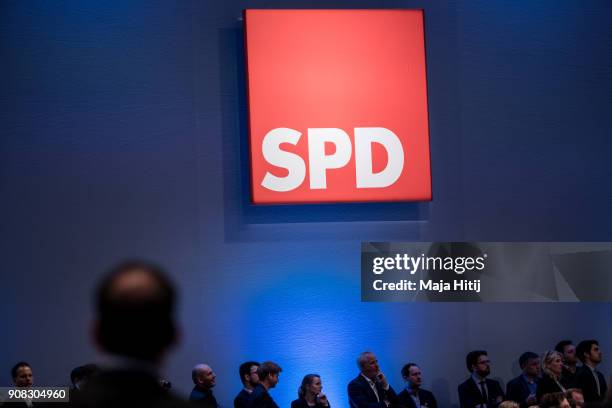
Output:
[458,350,504,408]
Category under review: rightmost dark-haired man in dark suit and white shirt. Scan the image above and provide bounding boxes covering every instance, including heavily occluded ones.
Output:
[576,340,608,404]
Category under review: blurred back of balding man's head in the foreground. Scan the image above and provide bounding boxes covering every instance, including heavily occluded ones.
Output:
[96,260,176,361]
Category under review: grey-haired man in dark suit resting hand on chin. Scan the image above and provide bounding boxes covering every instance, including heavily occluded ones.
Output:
[348,351,398,408]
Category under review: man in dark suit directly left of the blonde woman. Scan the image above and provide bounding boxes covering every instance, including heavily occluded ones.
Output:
[506,351,540,408]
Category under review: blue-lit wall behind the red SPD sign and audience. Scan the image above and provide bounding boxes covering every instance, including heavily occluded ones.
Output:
[0,0,612,407]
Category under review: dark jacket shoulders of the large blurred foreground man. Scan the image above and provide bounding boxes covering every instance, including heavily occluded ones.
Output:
[71,370,188,408]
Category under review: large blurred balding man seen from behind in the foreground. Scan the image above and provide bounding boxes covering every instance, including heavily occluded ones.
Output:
[73,261,186,408]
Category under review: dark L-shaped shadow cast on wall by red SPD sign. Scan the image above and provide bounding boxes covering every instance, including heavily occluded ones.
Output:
[219,21,429,241]
